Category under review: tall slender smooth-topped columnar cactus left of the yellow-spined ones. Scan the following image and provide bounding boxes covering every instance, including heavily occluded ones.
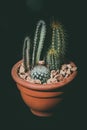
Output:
[32,20,46,66]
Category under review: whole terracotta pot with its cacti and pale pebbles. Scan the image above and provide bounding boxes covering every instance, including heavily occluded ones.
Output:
[11,20,77,117]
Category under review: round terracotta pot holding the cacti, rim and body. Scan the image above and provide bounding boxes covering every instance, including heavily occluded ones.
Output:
[11,61,77,116]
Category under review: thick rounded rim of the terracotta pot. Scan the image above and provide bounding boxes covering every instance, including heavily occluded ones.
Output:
[11,60,77,91]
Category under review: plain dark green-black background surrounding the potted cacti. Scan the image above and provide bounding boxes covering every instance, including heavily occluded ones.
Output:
[0,0,87,130]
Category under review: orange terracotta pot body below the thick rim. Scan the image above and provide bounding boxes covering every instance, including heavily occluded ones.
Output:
[17,84,63,116]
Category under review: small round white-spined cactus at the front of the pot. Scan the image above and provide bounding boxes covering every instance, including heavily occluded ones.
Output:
[30,65,50,83]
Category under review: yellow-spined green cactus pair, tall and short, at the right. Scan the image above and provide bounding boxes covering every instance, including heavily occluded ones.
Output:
[46,22,66,70]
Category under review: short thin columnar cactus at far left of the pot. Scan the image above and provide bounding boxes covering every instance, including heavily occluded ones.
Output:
[23,37,30,72]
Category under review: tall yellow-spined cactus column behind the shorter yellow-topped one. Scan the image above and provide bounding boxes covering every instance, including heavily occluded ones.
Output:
[52,22,66,58]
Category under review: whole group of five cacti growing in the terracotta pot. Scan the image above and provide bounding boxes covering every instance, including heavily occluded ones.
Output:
[23,20,66,83]
